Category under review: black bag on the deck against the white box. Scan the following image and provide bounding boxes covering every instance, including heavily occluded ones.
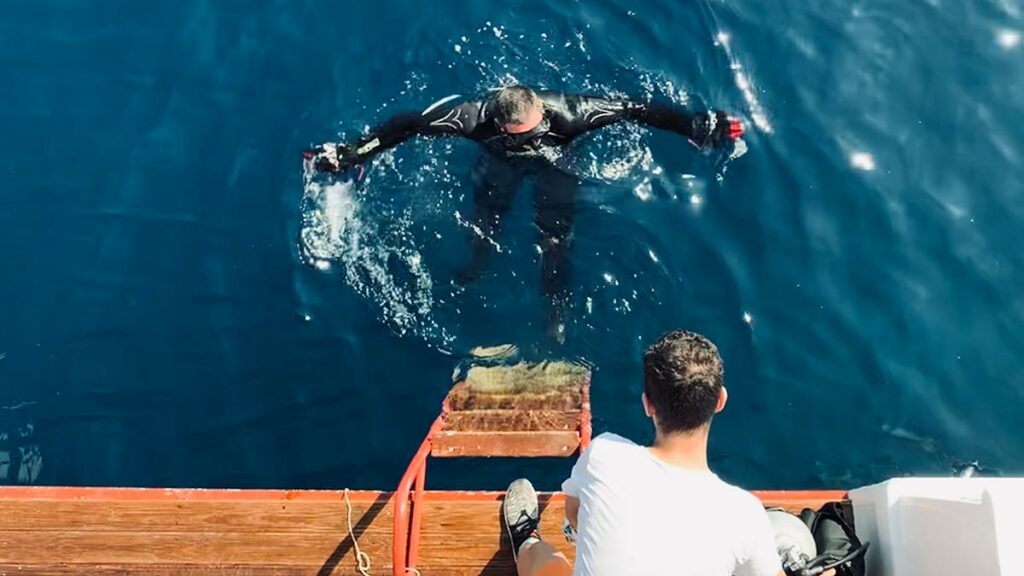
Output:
[800,502,870,576]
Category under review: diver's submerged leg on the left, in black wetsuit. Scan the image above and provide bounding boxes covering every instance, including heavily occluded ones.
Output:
[458,153,522,282]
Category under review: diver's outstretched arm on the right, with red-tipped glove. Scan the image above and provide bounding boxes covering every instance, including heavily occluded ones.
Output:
[563,94,743,150]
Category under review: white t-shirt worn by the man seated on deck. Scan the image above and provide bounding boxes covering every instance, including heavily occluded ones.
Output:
[562,434,782,576]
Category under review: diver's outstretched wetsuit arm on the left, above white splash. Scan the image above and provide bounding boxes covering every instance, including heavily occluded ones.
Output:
[303,97,480,172]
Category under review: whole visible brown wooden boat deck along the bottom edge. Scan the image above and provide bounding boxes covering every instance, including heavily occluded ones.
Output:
[0,487,845,576]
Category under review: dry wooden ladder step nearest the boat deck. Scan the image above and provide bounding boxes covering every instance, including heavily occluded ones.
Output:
[430,430,580,458]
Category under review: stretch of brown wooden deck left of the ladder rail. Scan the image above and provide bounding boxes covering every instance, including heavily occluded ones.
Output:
[0,489,393,575]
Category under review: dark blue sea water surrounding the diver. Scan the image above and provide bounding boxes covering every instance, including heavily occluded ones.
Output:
[0,0,1024,488]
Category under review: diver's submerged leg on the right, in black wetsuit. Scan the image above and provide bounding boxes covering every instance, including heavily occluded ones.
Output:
[534,168,580,342]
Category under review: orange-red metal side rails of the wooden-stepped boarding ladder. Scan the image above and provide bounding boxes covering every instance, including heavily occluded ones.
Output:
[391,378,593,576]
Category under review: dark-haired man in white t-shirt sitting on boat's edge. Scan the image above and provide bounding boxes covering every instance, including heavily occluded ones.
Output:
[504,331,783,576]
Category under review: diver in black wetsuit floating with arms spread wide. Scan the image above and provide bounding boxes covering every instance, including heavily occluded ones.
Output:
[304,86,743,342]
